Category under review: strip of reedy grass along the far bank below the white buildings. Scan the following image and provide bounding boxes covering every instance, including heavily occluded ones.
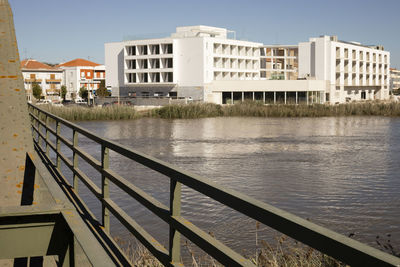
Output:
[40,101,400,121]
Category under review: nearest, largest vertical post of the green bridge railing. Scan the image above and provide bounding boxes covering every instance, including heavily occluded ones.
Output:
[169,178,182,263]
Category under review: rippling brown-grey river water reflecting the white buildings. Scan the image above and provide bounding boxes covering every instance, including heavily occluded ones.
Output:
[67,117,400,260]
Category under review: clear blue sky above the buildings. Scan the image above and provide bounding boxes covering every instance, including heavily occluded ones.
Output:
[9,0,400,68]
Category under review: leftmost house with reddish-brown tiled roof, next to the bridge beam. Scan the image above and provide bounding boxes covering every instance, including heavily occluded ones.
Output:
[21,59,63,102]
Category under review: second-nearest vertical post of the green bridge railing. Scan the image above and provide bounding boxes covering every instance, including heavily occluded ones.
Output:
[101,144,110,233]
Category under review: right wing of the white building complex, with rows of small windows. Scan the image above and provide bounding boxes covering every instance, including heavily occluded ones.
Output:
[299,36,390,103]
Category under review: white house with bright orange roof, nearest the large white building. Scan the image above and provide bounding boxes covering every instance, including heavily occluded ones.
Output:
[57,58,105,100]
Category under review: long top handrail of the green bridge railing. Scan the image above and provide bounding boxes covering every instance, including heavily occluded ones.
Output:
[28,107,400,266]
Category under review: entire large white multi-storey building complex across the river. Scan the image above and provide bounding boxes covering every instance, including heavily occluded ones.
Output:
[105,26,390,104]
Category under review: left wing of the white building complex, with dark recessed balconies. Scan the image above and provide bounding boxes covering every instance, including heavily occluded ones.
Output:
[105,26,261,100]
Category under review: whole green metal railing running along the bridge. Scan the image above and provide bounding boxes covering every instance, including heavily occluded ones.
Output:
[29,104,400,266]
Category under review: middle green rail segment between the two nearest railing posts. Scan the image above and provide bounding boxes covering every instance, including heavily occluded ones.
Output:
[102,169,169,222]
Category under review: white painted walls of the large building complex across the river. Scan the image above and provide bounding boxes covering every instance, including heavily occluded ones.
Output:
[105,25,390,103]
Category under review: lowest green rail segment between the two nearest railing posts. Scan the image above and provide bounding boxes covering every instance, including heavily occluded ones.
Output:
[103,198,169,265]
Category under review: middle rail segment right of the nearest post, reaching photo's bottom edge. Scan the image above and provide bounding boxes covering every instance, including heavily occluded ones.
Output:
[171,216,256,267]
